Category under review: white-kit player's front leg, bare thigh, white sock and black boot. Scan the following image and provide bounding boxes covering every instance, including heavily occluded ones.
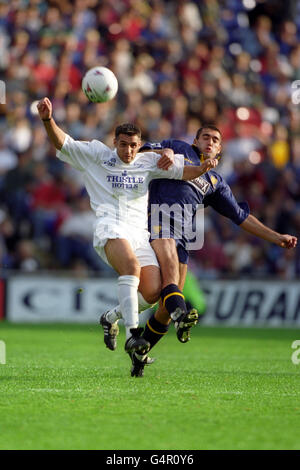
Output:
[101,238,150,354]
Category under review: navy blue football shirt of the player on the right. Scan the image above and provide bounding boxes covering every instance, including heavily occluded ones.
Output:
[140,139,250,264]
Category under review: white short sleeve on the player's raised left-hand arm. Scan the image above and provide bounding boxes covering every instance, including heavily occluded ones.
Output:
[56,135,108,171]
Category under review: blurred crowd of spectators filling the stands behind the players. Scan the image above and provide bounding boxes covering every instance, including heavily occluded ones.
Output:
[0,0,300,279]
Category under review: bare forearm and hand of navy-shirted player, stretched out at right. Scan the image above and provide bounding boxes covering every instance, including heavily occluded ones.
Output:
[240,214,297,249]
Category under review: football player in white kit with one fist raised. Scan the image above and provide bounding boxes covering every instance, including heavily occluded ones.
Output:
[37,98,218,368]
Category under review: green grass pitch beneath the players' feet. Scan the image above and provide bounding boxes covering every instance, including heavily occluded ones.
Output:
[0,322,300,450]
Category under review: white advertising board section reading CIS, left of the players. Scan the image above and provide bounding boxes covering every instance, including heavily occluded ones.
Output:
[6,276,118,323]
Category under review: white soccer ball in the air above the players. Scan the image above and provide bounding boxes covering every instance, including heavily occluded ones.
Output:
[82,67,118,103]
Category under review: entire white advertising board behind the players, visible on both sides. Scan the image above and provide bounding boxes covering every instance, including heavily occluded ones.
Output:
[6,276,300,328]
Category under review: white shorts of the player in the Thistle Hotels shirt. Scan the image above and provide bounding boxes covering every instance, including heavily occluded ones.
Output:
[93,224,159,268]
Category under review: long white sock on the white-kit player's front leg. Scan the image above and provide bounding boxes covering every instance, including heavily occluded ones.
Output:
[118,275,140,339]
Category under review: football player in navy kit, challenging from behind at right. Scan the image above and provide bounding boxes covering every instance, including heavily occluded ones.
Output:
[132,125,297,376]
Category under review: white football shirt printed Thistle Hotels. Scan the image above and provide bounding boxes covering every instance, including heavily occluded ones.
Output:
[56,135,184,231]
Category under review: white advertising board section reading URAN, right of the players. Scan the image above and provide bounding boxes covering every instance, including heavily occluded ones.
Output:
[201,280,300,328]
